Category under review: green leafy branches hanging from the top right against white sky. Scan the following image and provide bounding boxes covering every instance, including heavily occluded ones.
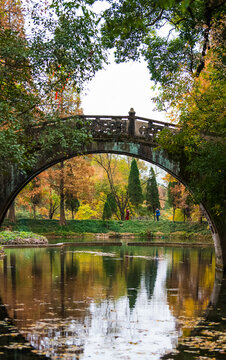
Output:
[102,0,225,108]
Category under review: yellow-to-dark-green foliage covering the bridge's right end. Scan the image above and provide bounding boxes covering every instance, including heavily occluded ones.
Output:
[159,23,226,219]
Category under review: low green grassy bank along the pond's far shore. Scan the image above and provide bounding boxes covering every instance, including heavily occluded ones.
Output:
[3,219,211,242]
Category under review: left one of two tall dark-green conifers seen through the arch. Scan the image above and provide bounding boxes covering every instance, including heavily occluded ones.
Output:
[128,159,143,207]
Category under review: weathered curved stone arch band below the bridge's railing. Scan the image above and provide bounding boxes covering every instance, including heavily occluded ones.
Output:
[0,139,226,268]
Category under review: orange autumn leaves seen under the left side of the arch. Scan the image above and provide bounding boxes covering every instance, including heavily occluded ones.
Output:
[17,157,94,218]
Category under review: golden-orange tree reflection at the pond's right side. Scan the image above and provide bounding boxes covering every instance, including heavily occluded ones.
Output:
[167,248,215,335]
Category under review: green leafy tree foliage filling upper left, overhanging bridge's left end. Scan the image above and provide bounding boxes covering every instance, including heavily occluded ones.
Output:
[0,1,104,173]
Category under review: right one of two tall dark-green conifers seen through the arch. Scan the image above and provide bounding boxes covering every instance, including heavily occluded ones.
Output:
[146,167,160,217]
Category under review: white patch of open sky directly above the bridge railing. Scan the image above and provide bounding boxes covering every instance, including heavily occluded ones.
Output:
[81,57,166,121]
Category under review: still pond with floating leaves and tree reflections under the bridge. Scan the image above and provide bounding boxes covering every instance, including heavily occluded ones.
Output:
[0,244,224,360]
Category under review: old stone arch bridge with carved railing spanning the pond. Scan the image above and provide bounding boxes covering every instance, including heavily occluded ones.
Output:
[0,109,226,269]
